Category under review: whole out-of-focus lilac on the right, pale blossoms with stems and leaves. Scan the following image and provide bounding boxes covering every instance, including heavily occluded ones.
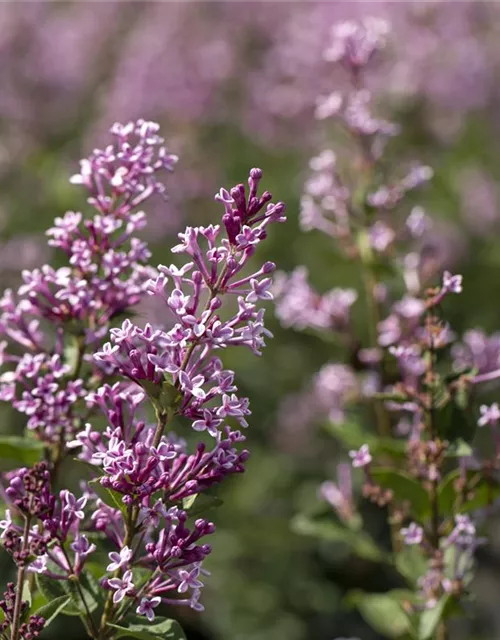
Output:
[276,21,500,637]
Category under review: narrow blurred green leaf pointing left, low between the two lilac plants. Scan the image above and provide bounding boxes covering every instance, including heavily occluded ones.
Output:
[291,515,384,560]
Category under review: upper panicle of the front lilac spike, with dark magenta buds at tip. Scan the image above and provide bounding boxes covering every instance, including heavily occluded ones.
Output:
[95,169,285,437]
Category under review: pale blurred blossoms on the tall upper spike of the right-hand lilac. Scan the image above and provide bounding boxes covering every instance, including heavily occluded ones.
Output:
[276,19,436,440]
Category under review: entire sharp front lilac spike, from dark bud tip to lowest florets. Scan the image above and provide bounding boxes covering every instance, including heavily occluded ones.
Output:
[69,169,285,623]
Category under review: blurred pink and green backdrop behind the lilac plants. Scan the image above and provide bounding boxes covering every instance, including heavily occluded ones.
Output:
[0,0,500,640]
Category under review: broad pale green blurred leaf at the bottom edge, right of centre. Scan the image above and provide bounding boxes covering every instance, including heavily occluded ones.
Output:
[347,589,414,638]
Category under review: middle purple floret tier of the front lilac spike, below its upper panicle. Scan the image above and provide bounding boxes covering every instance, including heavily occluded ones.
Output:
[73,383,248,504]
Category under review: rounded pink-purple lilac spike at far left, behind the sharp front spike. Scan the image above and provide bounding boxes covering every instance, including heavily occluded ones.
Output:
[0,120,177,443]
